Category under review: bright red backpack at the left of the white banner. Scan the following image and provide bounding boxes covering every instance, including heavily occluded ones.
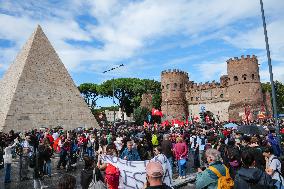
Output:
[105,163,120,189]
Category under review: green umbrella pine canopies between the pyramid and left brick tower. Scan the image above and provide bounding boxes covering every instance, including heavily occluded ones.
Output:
[78,78,161,119]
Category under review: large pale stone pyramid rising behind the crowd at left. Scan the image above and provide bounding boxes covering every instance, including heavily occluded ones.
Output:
[0,26,98,132]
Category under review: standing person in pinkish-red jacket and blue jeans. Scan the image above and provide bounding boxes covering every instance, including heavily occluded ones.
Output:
[174,137,188,179]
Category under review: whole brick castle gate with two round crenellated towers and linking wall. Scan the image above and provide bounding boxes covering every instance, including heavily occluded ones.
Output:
[161,55,272,121]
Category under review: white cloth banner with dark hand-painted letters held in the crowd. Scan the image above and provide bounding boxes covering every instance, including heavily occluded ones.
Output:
[101,155,172,189]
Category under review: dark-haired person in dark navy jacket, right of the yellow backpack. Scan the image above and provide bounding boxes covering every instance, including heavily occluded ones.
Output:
[234,150,275,189]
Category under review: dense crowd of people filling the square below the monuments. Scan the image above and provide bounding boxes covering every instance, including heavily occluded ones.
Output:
[0,120,284,189]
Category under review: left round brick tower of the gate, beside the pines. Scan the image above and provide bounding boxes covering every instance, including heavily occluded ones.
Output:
[161,69,189,120]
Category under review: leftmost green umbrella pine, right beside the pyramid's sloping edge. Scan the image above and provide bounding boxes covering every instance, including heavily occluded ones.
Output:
[78,83,100,110]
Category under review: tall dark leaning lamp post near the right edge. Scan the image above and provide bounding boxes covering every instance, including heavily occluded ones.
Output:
[259,0,279,134]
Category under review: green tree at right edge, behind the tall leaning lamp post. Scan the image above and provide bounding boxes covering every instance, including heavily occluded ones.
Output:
[261,81,284,114]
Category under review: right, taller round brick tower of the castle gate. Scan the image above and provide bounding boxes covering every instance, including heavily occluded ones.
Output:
[227,55,263,118]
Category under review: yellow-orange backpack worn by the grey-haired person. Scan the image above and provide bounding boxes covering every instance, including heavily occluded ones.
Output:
[208,165,234,189]
